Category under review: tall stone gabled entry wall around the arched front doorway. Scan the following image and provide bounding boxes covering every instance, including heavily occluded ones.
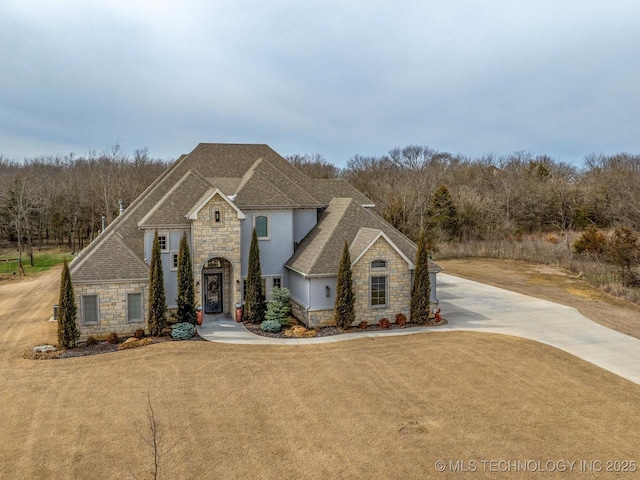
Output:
[191,195,242,314]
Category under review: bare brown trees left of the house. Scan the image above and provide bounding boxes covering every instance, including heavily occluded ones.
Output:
[0,144,168,253]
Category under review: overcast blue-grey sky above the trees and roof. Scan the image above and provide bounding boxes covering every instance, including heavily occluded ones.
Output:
[0,0,640,166]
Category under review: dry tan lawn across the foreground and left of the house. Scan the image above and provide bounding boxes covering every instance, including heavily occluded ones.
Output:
[0,264,640,479]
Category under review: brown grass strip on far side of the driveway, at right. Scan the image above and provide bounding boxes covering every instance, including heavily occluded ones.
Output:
[438,258,640,339]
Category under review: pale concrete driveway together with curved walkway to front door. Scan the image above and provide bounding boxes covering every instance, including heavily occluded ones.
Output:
[198,273,640,384]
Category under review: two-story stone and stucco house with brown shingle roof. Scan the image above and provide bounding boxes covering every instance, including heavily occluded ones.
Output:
[70,144,440,338]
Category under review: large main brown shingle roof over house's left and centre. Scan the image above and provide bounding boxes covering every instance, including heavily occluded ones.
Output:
[70,143,384,281]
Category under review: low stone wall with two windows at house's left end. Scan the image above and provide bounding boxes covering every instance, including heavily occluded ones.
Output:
[73,282,149,341]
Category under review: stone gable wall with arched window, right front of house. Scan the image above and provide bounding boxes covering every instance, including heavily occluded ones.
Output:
[351,237,411,325]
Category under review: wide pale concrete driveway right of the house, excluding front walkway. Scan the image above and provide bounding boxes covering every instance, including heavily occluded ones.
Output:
[438,273,640,384]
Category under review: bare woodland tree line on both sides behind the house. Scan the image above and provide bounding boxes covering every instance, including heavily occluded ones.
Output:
[0,145,640,258]
